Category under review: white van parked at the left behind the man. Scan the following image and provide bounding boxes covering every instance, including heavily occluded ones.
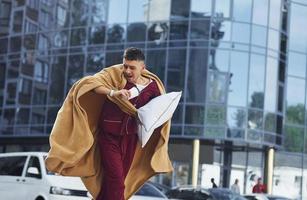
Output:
[0,152,91,200]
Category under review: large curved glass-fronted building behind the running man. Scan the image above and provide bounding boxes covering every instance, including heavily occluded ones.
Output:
[0,0,307,199]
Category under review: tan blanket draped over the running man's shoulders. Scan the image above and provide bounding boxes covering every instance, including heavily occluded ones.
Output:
[45,64,173,199]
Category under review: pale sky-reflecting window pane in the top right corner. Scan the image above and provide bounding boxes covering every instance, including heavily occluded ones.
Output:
[289,4,307,52]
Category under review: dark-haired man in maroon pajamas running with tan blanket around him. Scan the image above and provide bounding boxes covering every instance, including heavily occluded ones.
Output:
[46,48,176,200]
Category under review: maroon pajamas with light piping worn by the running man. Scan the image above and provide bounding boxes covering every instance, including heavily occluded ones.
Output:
[97,81,160,200]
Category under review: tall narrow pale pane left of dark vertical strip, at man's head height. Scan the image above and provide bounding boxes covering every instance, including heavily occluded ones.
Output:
[264,58,278,112]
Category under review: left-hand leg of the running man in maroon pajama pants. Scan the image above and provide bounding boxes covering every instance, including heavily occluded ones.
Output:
[97,133,125,200]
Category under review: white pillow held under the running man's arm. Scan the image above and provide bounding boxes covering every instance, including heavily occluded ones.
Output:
[137,92,182,147]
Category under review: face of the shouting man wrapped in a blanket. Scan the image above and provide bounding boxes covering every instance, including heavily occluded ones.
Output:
[123,59,145,83]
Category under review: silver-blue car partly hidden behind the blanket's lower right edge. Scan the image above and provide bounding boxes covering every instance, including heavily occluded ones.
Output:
[129,182,168,200]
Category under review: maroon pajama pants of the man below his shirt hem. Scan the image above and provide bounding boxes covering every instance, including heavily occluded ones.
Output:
[96,132,138,200]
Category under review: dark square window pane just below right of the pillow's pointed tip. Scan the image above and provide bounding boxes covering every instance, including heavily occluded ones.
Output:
[185,105,205,125]
